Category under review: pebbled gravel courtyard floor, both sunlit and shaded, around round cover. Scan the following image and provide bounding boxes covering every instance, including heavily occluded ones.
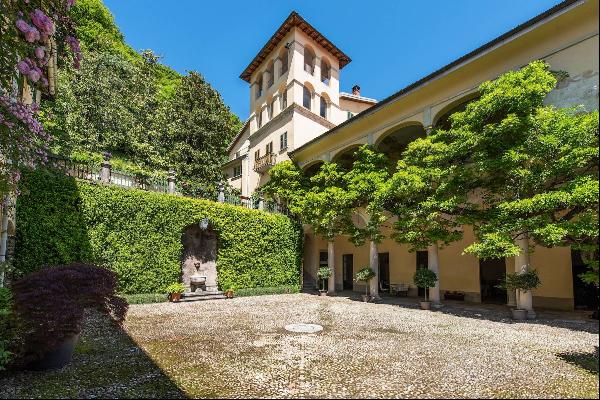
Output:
[0,294,598,398]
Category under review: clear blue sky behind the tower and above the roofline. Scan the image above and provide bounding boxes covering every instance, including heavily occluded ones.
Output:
[104,0,559,120]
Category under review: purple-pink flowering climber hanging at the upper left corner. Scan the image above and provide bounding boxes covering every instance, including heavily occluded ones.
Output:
[0,0,81,199]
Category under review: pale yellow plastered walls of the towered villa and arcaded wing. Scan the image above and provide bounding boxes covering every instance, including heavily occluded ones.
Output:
[226,0,599,309]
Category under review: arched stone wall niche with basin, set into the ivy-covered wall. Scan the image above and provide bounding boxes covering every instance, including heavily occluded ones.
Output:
[181,224,218,292]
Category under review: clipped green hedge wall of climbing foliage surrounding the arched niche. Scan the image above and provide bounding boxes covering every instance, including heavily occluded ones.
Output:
[14,170,303,293]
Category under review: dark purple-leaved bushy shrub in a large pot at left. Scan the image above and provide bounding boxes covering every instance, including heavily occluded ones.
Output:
[11,263,128,370]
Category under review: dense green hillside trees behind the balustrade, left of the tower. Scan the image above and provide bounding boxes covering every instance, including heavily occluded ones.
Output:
[42,0,241,195]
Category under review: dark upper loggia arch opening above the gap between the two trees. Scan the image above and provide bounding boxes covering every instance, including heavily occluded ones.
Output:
[375,122,427,170]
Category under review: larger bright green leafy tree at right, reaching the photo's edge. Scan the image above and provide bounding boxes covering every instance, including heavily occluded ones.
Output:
[398,61,598,284]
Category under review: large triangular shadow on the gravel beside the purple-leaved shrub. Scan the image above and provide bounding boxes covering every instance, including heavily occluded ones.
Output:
[0,312,187,399]
